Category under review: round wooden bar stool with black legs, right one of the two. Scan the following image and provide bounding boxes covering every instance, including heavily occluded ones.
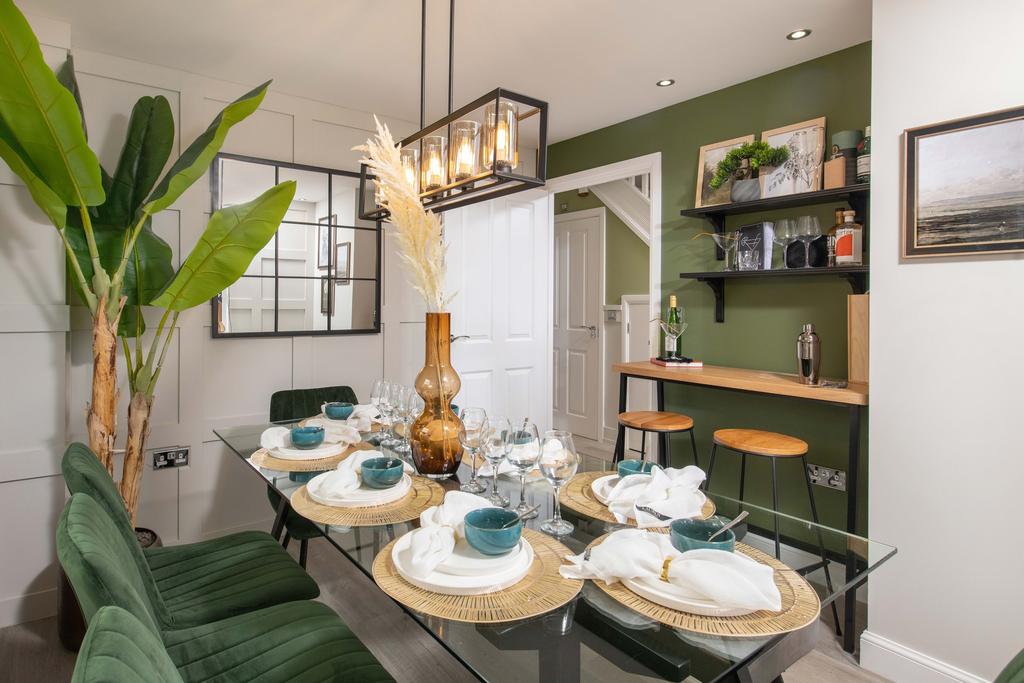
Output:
[705,429,842,635]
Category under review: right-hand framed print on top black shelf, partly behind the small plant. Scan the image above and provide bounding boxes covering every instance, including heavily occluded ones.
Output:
[760,117,825,197]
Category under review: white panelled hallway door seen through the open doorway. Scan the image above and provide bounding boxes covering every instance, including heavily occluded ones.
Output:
[552,209,604,440]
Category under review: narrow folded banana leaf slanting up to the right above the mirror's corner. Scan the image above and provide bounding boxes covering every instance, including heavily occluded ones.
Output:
[146,83,270,215]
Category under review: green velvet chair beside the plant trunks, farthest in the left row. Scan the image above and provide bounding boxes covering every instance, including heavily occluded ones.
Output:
[60,443,319,627]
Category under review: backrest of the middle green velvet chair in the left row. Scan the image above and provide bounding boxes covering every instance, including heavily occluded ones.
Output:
[57,494,171,637]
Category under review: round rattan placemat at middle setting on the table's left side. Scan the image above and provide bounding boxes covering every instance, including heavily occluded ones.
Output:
[292,476,444,526]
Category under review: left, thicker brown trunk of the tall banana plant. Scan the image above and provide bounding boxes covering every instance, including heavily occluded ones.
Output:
[86,299,120,476]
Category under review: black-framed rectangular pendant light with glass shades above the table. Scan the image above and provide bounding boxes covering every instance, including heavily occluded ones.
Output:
[359,0,548,220]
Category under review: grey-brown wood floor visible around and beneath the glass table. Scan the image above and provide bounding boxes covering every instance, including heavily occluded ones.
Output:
[0,541,884,683]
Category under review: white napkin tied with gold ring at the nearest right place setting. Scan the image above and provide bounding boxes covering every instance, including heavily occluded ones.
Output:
[558,528,782,611]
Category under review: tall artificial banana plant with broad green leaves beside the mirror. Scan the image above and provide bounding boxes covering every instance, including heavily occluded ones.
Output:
[0,0,295,521]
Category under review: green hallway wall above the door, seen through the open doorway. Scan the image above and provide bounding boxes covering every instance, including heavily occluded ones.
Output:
[555,189,650,304]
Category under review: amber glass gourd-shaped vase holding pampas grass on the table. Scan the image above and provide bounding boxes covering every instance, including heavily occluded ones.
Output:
[410,313,462,479]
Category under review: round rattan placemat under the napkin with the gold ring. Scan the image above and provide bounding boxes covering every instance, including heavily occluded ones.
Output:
[590,533,821,638]
